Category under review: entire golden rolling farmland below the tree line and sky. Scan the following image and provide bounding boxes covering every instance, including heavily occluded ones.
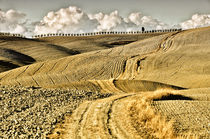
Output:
[0,27,210,139]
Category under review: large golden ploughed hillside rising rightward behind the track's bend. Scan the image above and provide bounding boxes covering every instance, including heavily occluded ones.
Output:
[0,28,210,91]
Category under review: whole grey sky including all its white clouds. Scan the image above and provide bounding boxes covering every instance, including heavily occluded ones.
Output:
[0,0,210,34]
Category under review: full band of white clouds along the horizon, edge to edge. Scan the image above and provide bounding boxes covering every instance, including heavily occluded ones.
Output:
[0,6,210,35]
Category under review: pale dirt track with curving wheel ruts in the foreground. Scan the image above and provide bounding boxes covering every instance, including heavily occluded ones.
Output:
[48,94,141,139]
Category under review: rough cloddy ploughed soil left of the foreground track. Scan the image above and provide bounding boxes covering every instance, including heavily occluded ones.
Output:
[0,86,111,138]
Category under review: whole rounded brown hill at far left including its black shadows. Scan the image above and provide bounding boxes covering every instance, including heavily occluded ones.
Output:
[0,36,80,72]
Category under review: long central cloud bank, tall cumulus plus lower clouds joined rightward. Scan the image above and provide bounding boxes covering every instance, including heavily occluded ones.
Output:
[34,6,168,34]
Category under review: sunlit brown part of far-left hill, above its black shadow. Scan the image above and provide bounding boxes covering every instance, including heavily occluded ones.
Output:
[0,37,76,62]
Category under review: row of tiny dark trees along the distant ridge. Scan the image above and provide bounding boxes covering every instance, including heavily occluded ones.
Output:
[0,27,182,38]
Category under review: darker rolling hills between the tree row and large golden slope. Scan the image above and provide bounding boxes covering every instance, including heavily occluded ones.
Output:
[0,33,165,72]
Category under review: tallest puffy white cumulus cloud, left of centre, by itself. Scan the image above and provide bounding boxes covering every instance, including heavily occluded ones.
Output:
[34,6,97,34]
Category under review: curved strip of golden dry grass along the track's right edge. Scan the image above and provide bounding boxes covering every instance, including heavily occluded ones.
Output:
[128,90,198,139]
